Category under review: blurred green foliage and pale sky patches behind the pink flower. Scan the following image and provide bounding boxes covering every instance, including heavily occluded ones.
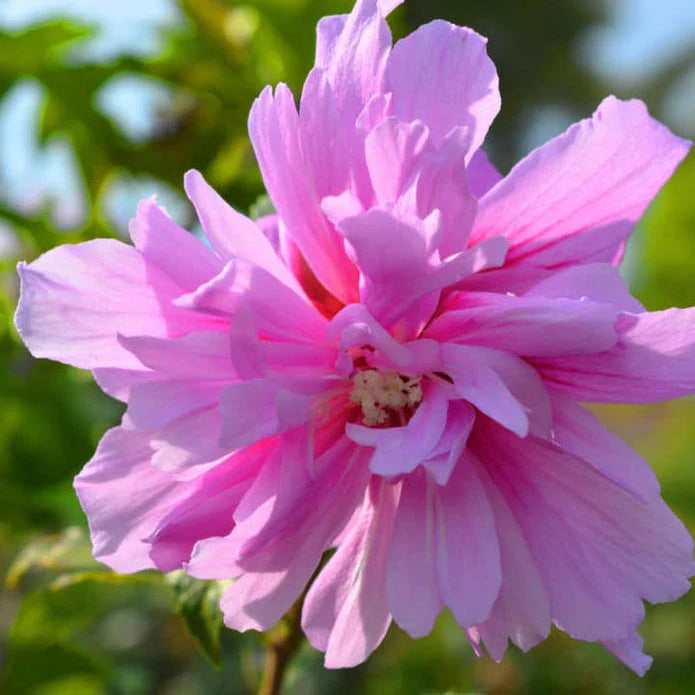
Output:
[0,0,695,695]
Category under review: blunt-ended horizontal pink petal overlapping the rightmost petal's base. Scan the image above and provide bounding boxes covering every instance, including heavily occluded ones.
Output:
[427,292,618,357]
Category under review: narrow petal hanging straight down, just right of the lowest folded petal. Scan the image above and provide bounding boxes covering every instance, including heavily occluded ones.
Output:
[386,470,443,638]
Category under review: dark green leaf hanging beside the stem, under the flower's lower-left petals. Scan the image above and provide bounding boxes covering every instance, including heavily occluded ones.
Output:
[167,570,226,668]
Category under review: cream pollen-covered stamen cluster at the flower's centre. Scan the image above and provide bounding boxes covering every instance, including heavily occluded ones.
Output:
[350,369,422,427]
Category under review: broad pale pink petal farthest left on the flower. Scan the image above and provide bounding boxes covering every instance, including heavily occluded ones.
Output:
[15,239,209,370]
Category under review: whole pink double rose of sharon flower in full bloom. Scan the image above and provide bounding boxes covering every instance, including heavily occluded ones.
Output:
[16,0,695,674]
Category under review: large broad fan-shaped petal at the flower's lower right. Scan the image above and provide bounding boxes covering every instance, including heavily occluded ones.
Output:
[473,424,695,642]
